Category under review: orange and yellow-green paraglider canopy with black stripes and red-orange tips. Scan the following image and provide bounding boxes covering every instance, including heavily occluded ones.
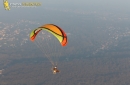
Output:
[30,24,67,46]
